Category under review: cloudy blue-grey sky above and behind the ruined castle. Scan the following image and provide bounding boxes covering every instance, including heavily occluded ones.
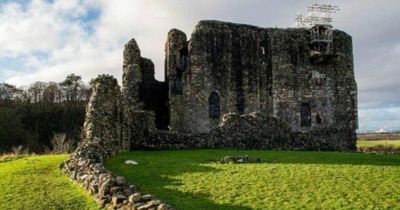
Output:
[0,0,400,131]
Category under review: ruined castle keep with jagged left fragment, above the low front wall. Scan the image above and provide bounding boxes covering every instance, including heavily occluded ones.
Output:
[122,21,357,150]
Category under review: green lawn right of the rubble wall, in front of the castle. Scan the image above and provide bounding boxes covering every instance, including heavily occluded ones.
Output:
[106,150,400,210]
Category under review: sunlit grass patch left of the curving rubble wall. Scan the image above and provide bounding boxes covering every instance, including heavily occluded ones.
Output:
[0,155,98,210]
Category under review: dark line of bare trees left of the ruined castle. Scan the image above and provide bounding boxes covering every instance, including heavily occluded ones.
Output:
[0,74,91,153]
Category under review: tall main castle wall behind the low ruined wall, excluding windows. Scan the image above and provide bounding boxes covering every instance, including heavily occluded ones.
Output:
[170,21,357,142]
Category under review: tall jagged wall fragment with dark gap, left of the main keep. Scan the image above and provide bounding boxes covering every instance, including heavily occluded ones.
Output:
[122,39,169,147]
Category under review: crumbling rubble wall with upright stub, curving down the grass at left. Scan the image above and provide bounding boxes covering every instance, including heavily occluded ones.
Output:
[61,75,171,210]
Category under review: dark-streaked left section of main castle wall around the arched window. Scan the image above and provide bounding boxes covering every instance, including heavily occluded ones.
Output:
[180,21,272,132]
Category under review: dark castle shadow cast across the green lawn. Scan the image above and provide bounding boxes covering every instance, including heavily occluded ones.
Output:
[106,150,400,210]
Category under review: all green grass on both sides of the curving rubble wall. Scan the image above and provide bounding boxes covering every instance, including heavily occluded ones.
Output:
[0,140,400,210]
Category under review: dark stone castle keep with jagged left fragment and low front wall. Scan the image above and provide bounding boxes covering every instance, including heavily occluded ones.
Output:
[118,21,357,150]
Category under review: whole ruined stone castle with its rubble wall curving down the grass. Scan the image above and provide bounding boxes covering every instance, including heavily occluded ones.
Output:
[61,21,357,210]
